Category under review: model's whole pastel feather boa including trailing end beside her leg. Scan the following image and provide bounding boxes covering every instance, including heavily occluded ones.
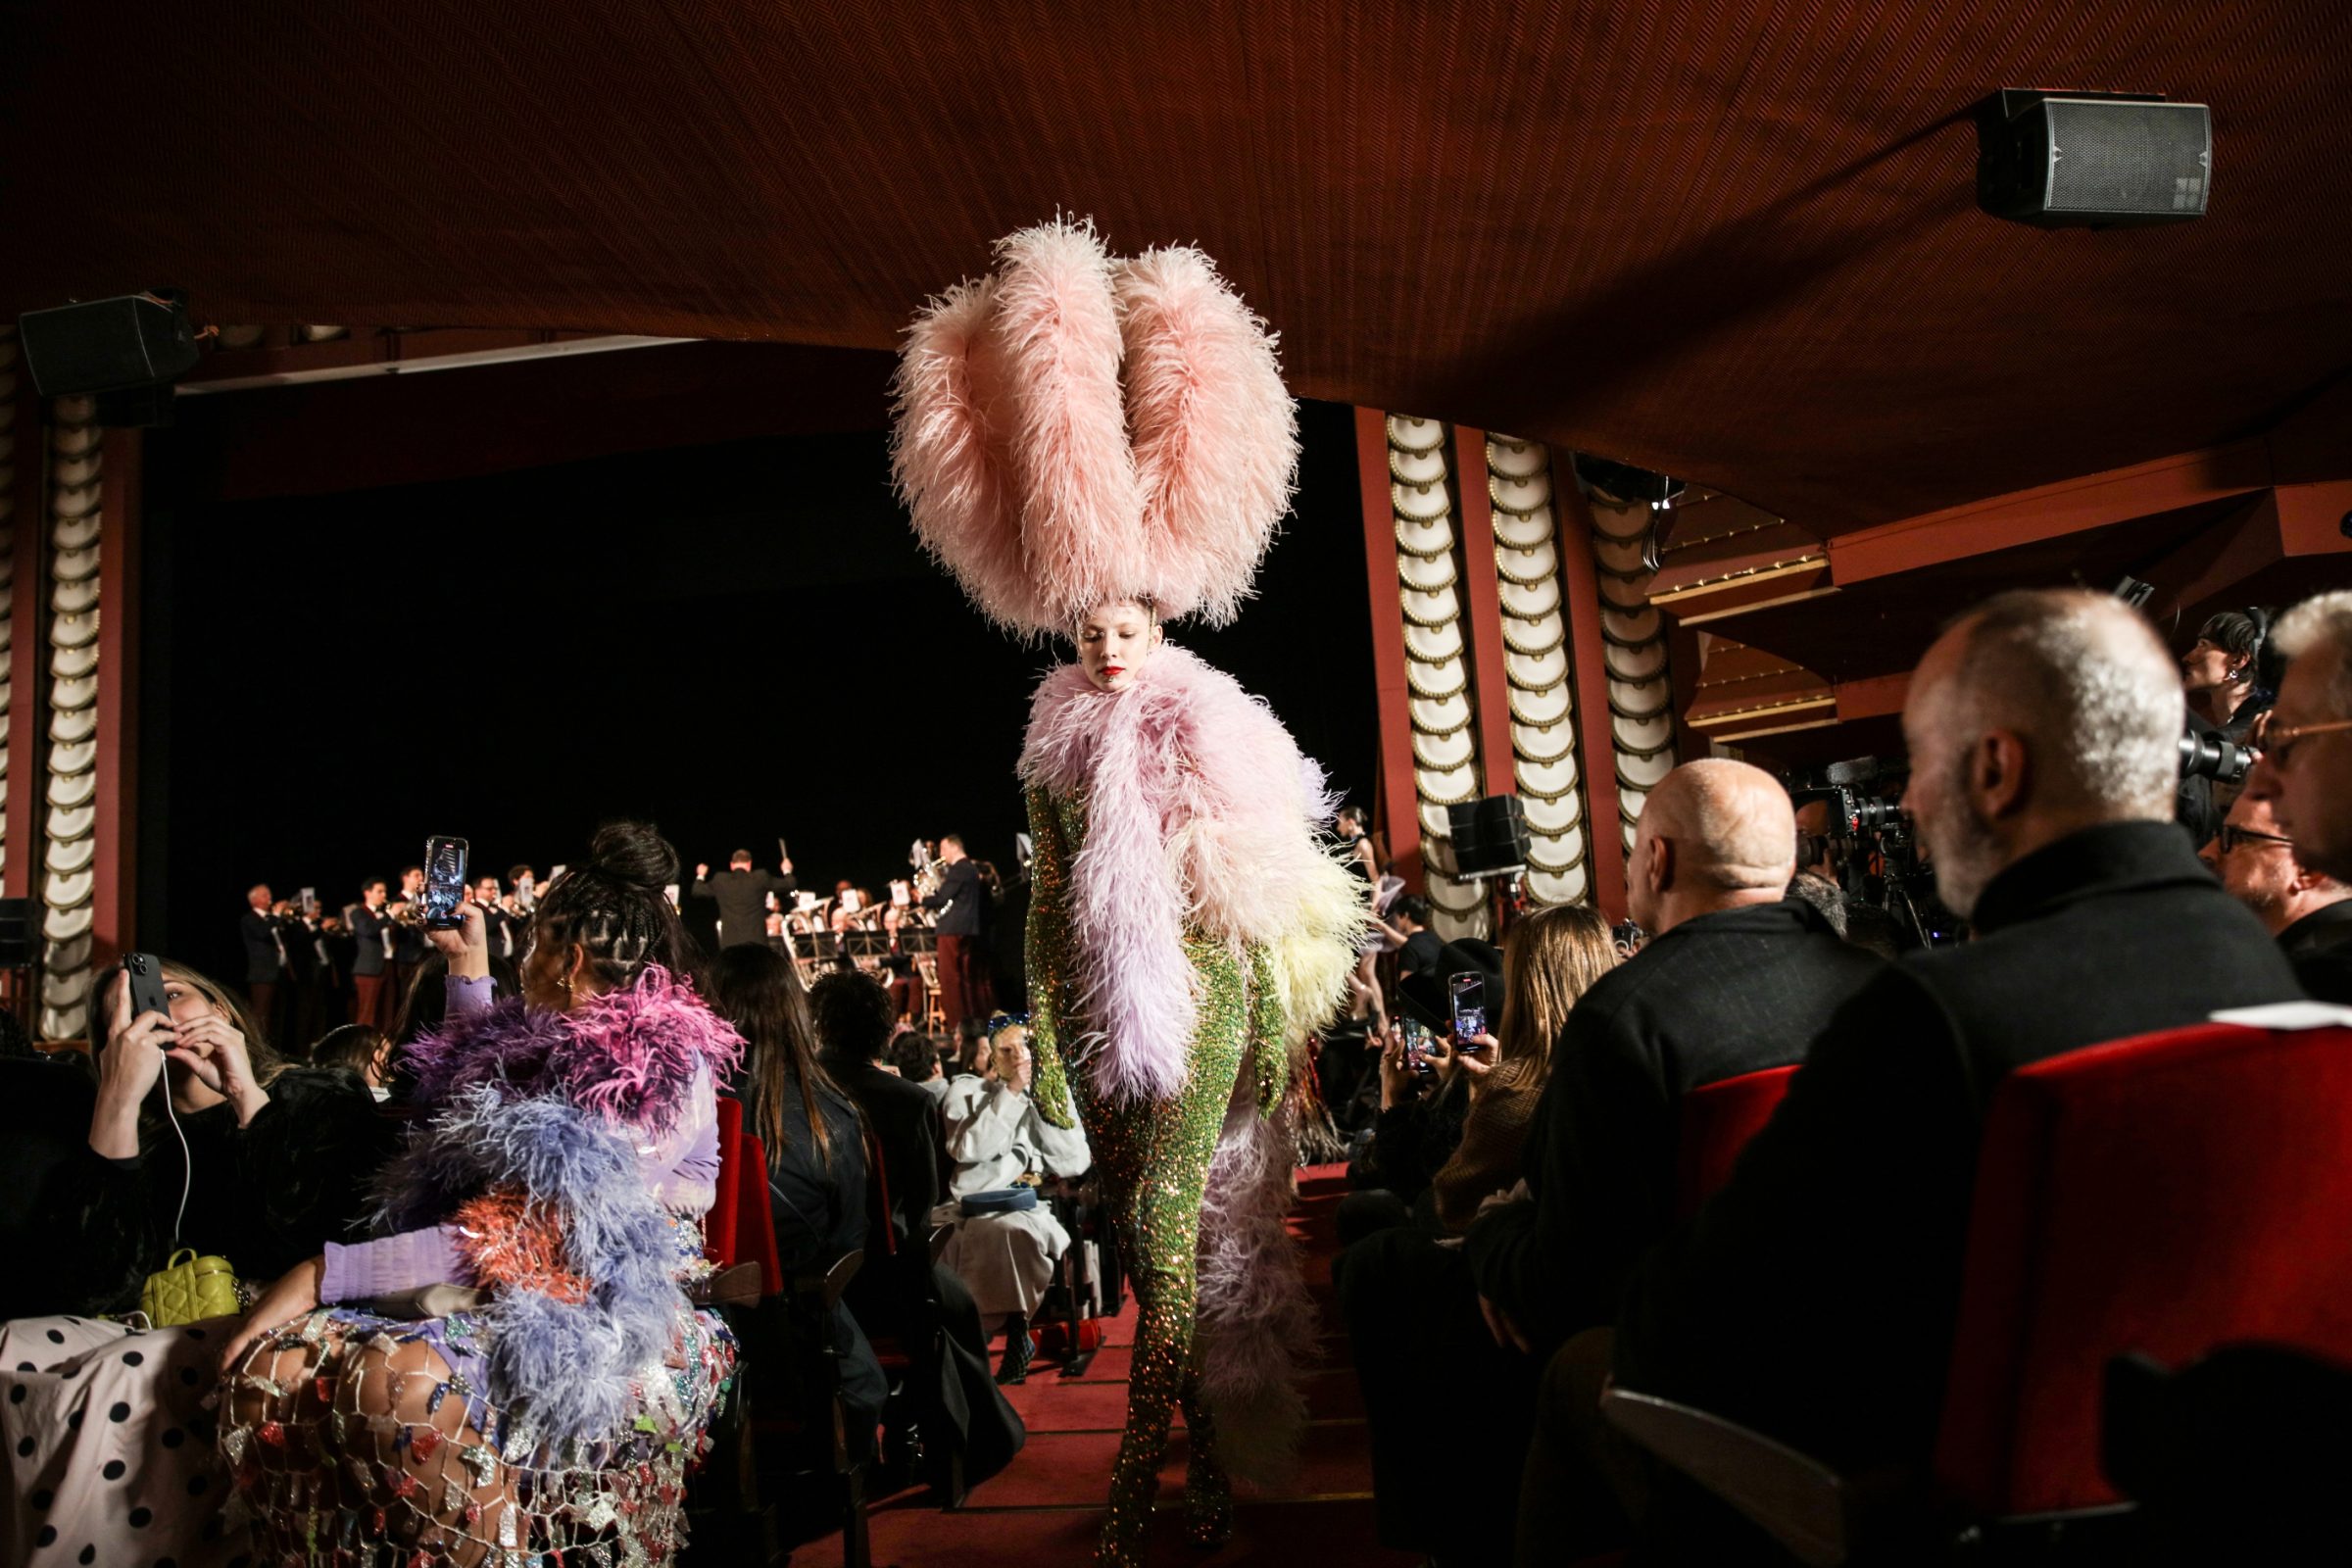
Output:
[1021,644,1366,1486]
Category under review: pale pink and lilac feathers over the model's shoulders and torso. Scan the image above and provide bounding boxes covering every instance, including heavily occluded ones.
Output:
[1021,644,1336,1101]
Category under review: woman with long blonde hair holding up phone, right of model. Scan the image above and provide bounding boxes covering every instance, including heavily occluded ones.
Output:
[1430,903,1618,1234]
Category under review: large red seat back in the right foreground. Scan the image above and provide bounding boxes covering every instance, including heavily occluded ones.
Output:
[1936,1025,2352,1519]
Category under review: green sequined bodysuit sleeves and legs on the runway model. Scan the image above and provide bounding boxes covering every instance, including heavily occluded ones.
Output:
[1028,790,1284,1561]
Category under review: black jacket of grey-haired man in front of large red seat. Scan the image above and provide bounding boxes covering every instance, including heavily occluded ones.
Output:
[1616,823,2300,1469]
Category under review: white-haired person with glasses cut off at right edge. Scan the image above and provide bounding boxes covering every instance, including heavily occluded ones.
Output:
[2246,590,2352,884]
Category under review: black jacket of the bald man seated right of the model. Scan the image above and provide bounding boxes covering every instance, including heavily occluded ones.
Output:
[1468,898,1886,1349]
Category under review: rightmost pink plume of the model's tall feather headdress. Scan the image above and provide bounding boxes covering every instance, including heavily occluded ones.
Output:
[1115,247,1298,625]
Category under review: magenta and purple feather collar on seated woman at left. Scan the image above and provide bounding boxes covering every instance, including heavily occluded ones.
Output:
[407,964,743,1138]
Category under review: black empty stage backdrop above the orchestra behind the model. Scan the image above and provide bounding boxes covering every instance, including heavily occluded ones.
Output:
[139,393,1376,980]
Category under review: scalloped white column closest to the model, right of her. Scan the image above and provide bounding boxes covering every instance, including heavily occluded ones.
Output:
[1388,414,1489,941]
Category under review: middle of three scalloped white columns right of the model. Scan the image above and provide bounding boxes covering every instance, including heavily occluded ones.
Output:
[1487,432,1592,903]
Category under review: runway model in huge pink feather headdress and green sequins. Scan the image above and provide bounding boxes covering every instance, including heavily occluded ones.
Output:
[894,223,1369,1566]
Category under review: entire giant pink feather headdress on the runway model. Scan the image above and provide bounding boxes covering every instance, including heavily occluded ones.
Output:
[892,219,1298,632]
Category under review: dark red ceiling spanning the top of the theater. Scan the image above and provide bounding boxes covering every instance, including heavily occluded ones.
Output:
[0,0,2352,534]
